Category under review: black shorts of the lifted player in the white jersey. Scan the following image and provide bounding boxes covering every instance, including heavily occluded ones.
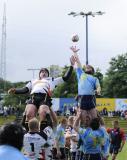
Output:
[27,93,52,109]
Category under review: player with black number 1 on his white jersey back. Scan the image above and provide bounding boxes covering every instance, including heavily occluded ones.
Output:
[23,118,53,160]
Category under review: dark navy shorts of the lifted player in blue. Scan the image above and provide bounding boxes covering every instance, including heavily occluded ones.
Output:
[78,95,96,110]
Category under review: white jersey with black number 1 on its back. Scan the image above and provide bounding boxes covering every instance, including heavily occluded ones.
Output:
[23,126,53,160]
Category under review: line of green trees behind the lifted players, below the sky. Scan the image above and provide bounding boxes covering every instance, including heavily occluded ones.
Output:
[0,53,127,106]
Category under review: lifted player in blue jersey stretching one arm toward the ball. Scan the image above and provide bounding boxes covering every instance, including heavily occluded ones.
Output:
[71,47,101,123]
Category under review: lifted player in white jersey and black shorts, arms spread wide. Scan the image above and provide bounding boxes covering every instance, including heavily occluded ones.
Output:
[8,56,75,129]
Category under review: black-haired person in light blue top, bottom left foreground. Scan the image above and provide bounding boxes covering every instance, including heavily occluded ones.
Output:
[0,122,27,160]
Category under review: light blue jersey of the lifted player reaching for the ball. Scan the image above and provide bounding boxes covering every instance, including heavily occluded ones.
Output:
[76,68,100,95]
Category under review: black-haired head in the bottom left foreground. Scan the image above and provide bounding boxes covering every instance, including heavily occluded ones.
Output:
[0,122,24,150]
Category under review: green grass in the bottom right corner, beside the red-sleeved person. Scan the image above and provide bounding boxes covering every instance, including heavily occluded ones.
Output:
[108,142,127,160]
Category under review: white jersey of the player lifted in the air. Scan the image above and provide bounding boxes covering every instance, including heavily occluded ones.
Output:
[26,77,64,94]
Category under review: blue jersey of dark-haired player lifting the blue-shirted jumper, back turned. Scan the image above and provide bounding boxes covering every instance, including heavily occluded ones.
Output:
[81,128,104,154]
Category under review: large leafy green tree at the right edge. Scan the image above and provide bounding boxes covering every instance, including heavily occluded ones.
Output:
[103,53,127,98]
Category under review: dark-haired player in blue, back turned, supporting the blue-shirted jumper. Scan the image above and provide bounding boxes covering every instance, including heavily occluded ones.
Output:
[81,118,104,160]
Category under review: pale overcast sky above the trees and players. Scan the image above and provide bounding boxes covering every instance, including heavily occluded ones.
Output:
[0,0,127,82]
